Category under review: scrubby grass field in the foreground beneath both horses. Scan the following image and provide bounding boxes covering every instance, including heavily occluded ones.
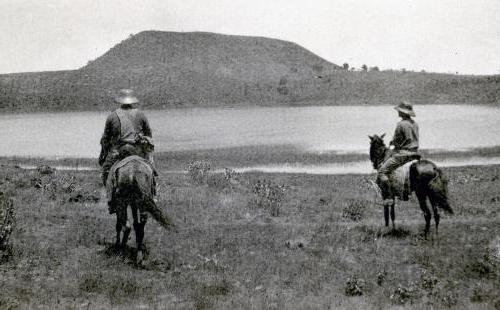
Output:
[0,156,500,309]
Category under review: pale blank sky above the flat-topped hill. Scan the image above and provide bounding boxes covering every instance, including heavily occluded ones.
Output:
[0,0,500,75]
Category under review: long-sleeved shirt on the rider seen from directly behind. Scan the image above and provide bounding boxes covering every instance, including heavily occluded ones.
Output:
[101,105,152,152]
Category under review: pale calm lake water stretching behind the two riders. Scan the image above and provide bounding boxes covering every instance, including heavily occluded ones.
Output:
[0,105,500,158]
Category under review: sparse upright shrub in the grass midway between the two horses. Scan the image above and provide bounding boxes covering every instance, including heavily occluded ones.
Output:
[252,179,286,216]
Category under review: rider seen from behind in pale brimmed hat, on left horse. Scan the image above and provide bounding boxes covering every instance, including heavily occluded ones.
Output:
[99,89,154,214]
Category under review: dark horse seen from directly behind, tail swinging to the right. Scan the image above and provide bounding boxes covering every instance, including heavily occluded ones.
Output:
[114,157,174,265]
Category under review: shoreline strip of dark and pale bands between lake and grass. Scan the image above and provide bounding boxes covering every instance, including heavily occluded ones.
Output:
[0,145,500,174]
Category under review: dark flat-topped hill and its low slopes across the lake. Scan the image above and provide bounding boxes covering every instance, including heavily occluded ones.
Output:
[0,31,500,111]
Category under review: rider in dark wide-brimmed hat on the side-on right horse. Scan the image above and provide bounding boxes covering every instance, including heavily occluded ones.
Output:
[378,101,418,204]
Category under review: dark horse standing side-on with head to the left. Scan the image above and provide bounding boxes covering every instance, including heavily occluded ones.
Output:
[368,134,453,234]
